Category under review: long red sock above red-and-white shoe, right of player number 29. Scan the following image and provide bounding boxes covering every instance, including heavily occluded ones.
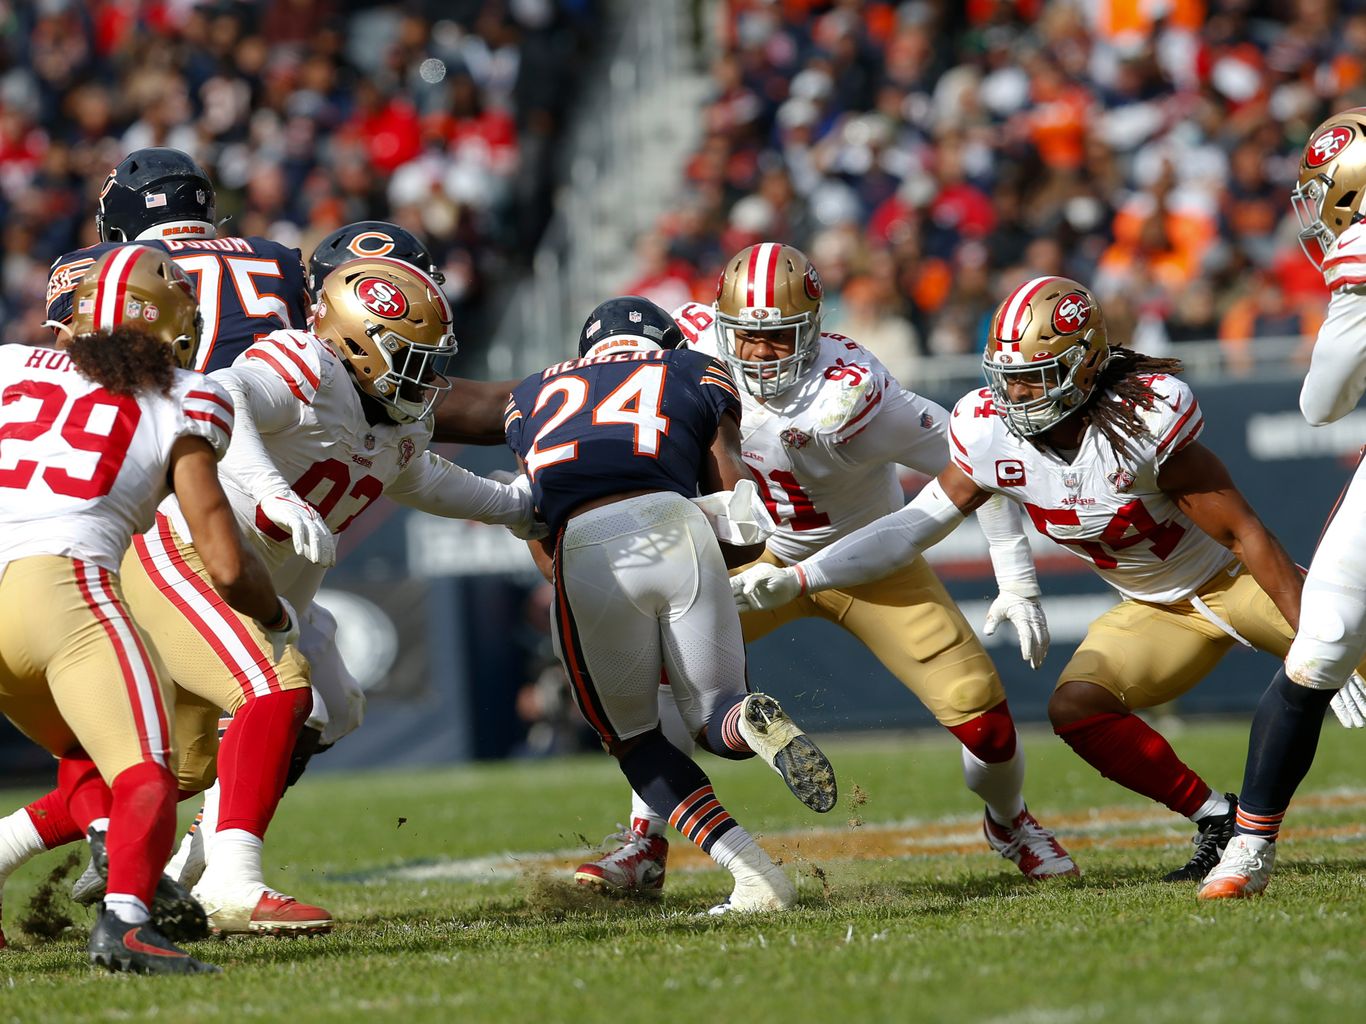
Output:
[214,688,313,841]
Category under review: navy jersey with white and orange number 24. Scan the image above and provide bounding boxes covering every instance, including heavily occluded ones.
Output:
[504,350,740,531]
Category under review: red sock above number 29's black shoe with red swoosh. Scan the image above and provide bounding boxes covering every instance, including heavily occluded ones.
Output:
[105,760,176,920]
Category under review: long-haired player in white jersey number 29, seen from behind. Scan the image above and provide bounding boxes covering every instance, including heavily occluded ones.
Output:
[0,246,298,973]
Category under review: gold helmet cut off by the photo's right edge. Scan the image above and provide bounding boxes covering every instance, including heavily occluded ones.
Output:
[1290,106,1366,270]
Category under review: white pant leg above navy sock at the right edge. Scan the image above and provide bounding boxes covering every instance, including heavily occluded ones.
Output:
[1285,461,1366,689]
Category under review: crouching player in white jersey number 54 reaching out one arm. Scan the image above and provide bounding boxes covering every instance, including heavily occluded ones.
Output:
[734,277,1327,881]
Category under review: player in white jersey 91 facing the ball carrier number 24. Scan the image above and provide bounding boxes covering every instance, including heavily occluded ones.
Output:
[575,242,1076,894]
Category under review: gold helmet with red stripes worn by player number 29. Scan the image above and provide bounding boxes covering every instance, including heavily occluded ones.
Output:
[63,246,204,370]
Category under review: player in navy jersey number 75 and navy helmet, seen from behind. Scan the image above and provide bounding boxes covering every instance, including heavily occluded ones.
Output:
[48,147,309,371]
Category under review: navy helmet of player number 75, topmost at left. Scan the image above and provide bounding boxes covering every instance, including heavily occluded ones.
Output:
[94,147,214,242]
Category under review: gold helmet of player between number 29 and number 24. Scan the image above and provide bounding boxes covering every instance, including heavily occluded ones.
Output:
[313,257,458,423]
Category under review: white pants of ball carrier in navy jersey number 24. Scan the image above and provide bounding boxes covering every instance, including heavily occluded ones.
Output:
[552,492,746,743]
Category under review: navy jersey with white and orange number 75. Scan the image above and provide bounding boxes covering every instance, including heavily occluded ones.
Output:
[48,236,309,373]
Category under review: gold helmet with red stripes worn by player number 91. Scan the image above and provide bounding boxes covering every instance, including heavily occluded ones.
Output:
[716,242,824,399]
